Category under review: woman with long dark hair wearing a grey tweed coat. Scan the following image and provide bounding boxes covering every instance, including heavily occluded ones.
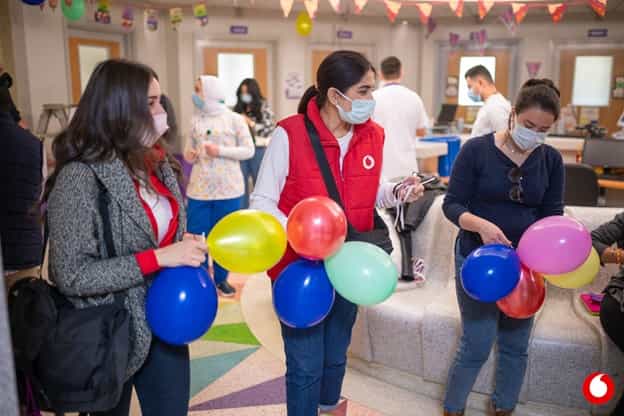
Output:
[44,60,206,416]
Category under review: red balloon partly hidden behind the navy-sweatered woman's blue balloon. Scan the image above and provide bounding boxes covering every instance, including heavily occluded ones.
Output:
[496,265,546,319]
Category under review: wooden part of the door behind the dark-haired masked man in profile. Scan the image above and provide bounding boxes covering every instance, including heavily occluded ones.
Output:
[444,49,511,122]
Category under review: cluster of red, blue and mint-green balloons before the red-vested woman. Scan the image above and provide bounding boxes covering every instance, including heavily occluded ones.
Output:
[273,196,398,328]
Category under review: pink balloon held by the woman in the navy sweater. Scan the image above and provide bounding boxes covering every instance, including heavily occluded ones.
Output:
[517,216,592,274]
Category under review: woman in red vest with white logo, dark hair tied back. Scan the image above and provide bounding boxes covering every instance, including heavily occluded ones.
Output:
[251,51,424,416]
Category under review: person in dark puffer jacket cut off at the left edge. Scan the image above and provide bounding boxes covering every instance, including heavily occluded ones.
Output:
[0,86,44,287]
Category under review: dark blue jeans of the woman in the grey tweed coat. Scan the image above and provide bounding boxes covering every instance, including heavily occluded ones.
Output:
[92,337,191,416]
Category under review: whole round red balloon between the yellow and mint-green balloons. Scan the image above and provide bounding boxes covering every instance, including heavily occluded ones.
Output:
[286,196,347,260]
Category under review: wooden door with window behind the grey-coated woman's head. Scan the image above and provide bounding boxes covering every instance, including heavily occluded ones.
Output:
[69,37,121,104]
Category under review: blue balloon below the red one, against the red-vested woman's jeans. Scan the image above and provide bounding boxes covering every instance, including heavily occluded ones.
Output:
[273,260,336,328]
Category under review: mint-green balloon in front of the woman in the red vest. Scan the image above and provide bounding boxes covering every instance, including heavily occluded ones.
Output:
[325,241,399,306]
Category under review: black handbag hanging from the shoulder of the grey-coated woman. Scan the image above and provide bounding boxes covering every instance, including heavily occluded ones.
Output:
[9,173,130,414]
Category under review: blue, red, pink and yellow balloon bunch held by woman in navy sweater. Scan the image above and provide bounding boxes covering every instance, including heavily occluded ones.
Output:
[461,216,600,319]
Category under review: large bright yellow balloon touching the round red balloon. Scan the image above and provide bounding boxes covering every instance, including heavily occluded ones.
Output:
[206,209,286,274]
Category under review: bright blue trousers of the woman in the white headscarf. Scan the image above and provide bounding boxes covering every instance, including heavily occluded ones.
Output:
[186,197,243,284]
